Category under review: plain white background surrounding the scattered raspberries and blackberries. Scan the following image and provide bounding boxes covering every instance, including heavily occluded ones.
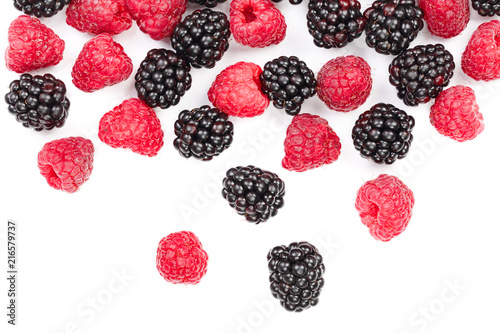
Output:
[0,1,500,333]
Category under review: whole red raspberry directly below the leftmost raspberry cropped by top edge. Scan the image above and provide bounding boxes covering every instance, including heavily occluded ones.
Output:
[71,34,133,92]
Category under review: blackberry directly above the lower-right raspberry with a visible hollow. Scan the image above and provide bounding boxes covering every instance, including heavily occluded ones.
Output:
[352,103,415,164]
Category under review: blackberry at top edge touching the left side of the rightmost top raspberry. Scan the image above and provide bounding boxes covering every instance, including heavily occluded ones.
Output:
[363,0,424,55]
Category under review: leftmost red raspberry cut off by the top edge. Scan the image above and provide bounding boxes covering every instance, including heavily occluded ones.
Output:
[66,0,132,35]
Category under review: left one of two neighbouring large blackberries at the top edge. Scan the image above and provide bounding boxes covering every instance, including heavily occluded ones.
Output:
[307,0,366,49]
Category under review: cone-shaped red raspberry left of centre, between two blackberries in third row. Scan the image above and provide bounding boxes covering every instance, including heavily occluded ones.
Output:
[98,98,163,157]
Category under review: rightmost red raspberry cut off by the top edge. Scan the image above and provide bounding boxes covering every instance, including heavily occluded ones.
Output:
[419,0,470,38]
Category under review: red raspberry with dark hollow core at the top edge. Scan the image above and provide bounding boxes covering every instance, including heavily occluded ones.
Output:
[229,0,286,47]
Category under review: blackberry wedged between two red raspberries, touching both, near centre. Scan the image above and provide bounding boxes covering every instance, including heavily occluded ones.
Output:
[259,56,317,115]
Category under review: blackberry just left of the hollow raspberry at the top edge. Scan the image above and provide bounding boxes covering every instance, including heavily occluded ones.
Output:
[171,8,231,68]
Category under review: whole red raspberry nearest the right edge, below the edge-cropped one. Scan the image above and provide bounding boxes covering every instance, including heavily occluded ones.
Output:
[429,85,484,142]
